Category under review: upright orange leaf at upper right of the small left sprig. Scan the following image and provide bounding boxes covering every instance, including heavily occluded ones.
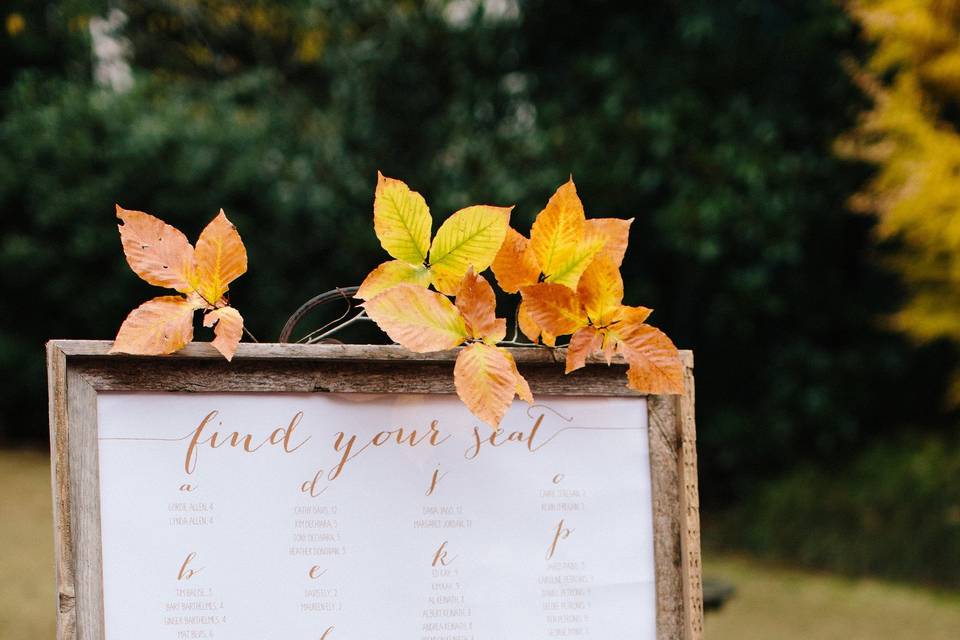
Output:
[194,209,247,305]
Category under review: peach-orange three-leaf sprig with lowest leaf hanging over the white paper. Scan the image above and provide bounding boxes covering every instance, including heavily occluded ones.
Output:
[363,267,533,427]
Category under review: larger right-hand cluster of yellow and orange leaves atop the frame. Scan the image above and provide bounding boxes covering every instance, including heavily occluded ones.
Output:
[357,174,683,427]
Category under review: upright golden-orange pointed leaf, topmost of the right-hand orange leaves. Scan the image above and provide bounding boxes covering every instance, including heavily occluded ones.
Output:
[530,178,587,286]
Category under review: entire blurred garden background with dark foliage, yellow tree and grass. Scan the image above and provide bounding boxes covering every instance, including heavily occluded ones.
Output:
[0,0,960,640]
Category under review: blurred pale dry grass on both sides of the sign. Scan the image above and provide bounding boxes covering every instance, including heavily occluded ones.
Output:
[0,451,960,640]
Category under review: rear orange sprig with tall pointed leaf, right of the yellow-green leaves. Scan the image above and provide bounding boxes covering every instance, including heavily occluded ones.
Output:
[492,178,633,346]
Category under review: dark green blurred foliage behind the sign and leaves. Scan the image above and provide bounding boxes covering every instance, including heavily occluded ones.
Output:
[0,0,955,508]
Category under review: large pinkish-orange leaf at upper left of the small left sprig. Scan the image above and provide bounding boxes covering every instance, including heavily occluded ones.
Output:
[117,205,193,293]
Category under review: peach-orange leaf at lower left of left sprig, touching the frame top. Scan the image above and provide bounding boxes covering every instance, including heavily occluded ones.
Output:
[110,296,197,356]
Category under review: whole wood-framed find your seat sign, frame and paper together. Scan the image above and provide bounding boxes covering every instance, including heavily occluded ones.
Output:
[47,341,702,640]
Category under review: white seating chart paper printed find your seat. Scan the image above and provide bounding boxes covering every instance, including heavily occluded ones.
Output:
[97,392,656,640]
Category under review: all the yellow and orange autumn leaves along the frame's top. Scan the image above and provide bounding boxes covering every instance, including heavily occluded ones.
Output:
[113,174,683,427]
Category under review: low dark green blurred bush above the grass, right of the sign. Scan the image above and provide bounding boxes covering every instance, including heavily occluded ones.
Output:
[705,438,960,588]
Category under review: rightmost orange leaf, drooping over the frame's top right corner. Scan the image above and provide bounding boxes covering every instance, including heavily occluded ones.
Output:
[615,322,683,394]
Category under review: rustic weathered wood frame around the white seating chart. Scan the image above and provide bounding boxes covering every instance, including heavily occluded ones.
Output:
[47,340,703,640]
